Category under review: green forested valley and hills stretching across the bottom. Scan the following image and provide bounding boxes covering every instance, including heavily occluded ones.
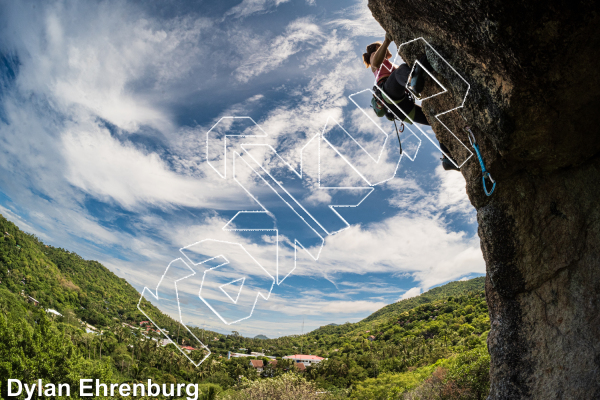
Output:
[0,216,489,400]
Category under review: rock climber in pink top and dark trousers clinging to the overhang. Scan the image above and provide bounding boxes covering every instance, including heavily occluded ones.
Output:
[363,33,459,170]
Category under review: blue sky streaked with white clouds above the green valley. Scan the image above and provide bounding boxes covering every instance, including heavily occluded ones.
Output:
[0,0,485,337]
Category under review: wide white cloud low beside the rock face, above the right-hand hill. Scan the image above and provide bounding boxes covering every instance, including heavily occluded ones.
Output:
[296,214,485,289]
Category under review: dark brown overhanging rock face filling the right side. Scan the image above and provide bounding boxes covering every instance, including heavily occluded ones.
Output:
[369,0,600,400]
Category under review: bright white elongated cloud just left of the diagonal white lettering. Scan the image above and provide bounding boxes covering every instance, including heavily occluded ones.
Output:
[62,119,248,209]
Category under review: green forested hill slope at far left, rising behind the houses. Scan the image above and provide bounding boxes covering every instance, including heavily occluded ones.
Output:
[0,215,214,341]
